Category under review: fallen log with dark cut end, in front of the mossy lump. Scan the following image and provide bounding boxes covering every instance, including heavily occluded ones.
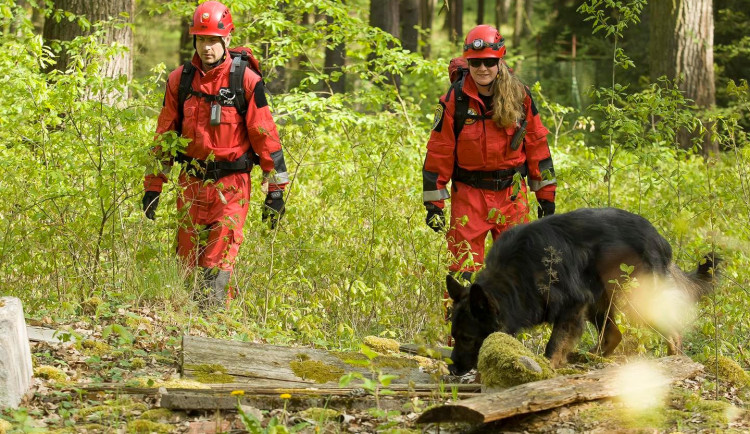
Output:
[417,356,703,424]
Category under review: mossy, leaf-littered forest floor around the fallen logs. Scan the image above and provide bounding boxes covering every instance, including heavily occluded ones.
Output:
[0,308,750,434]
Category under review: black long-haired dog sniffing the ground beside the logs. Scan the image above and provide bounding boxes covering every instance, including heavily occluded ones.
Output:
[447,208,718,375]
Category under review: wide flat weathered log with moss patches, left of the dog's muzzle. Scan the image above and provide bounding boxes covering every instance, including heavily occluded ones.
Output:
[180,336,433,388]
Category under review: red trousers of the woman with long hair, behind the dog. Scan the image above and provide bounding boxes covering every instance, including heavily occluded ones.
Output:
[445,182,529,272]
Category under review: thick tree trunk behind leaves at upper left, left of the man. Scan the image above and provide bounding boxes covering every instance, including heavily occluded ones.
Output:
[43,0,135,80]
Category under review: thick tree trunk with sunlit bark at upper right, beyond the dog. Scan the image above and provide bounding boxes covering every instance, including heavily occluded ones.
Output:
[649,0,718,155]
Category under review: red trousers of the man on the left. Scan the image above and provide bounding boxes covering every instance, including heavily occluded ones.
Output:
[177,173,250,271]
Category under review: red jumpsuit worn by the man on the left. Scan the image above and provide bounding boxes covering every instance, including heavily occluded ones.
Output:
[144,53,289,271]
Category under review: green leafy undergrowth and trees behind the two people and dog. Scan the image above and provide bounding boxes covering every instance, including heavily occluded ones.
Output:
[0,0,750,394]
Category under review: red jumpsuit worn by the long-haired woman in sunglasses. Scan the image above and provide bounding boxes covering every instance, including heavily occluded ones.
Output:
[422,75,556,272]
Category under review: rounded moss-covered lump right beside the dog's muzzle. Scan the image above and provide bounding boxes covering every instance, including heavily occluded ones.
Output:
[477,332,555,389]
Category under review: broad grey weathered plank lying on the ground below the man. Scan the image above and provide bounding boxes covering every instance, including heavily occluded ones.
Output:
[180,336,433,388]
